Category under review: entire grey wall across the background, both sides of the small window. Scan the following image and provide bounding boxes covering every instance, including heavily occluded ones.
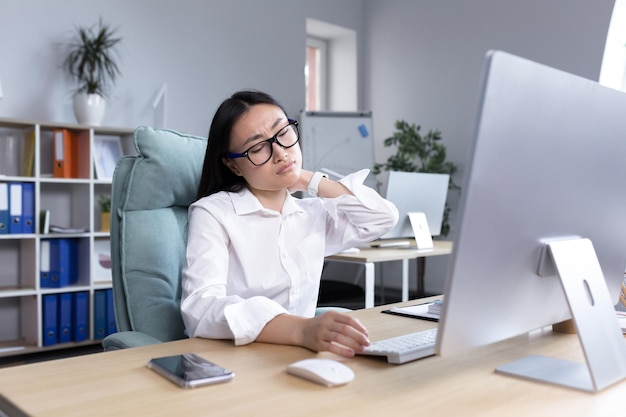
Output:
[0,0,613,292]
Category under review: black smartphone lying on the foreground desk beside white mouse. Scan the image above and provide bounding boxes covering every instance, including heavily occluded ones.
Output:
[146,353,235,388]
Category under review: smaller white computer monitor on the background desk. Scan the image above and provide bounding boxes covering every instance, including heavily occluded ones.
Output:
[381,171,450,239]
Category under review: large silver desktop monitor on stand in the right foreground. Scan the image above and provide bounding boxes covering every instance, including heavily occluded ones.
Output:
[436,51,626,391]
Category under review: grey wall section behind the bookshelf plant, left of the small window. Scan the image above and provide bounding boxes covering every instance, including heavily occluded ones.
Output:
[0,0,363,135]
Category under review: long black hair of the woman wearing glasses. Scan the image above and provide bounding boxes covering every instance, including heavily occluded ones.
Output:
[197,90,287,199]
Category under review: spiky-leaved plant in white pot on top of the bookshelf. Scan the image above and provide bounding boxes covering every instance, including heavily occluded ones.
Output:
[63,19,121,126]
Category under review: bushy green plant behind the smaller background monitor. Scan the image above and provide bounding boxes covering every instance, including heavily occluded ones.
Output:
[372,120,460,236]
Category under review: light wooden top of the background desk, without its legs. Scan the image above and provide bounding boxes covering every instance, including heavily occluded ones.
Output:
[327,240,452,262]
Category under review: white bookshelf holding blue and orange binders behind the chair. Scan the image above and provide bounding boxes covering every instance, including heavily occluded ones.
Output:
[0,118,135,357]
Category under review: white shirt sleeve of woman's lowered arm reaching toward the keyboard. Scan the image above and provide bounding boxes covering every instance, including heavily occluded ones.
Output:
[181,202,286,345]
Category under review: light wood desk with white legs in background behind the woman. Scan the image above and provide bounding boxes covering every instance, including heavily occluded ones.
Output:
[326,240,452,308]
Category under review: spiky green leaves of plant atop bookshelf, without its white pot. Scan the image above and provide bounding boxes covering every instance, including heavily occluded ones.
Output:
[63,19,122,96]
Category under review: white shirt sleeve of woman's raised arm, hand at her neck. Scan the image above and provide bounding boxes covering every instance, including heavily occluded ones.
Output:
[323,169,398,256]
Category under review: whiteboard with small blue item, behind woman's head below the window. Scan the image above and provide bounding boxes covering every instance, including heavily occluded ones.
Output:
[300,112,378,190]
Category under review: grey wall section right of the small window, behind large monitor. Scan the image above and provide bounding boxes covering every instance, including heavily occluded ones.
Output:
[364,0,613,292]
